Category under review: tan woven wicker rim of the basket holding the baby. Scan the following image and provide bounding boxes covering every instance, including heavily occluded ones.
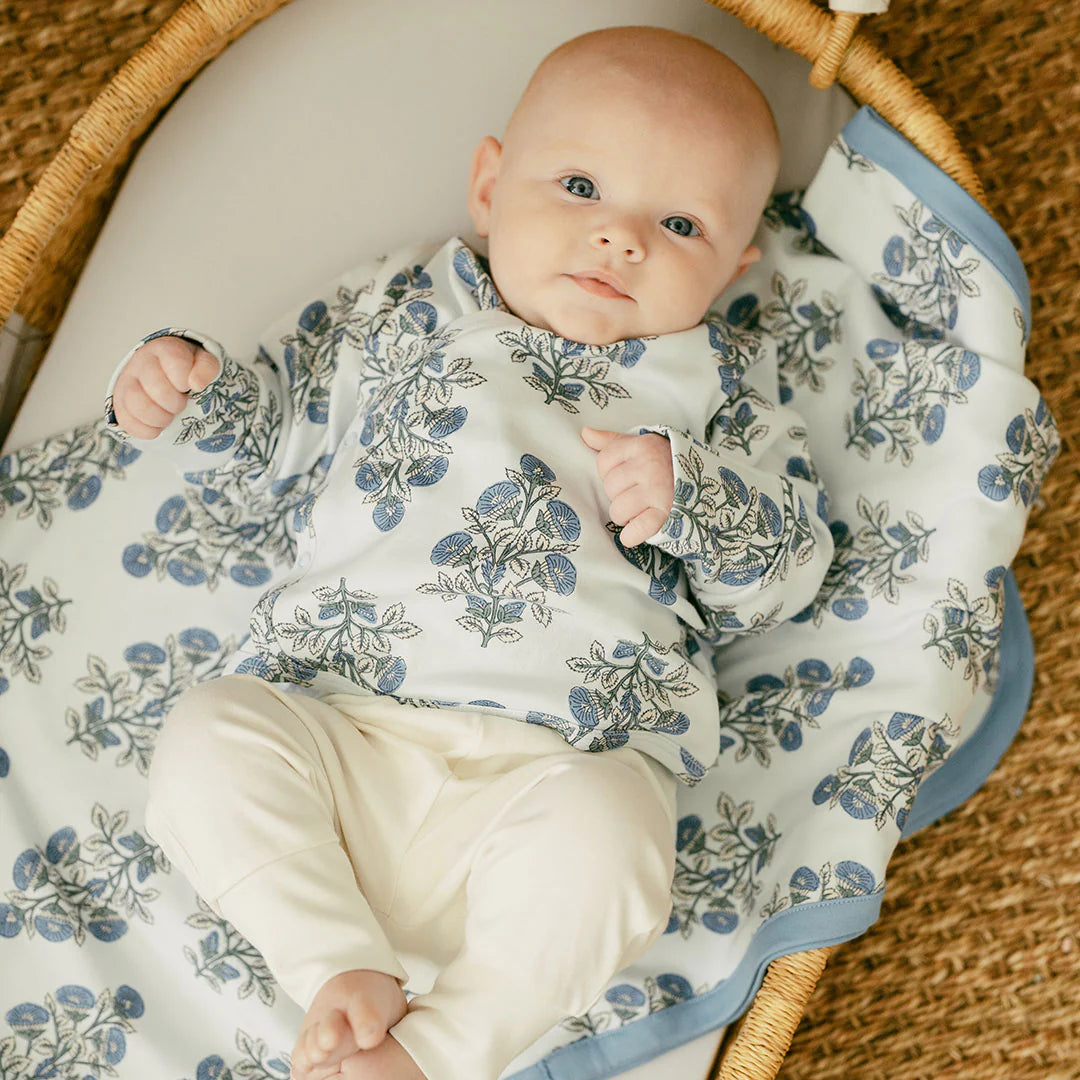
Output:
[0,0,1080,1080]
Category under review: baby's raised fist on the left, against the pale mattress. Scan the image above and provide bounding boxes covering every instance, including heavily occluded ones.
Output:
[112,337,218,438]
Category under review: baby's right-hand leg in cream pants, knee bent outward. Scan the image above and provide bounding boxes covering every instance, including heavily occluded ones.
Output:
[388,751,675,1080]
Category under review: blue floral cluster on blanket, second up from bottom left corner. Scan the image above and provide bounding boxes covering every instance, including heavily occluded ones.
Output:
[0,804,168,950]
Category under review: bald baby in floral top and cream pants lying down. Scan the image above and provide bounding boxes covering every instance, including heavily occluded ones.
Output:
[108,27,832,1080]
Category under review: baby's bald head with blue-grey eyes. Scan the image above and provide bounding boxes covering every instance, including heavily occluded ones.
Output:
[469,26,780,345]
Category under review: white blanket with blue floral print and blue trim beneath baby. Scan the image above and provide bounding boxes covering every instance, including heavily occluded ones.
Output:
[0,109,1058,1080]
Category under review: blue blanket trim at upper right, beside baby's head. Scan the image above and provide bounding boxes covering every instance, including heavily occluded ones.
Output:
[840,105,1031,326]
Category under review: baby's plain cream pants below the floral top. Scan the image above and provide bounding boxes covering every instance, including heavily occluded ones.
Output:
[146,675,676,1080]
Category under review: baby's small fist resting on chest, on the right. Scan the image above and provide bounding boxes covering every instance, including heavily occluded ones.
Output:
[581,428,675,548]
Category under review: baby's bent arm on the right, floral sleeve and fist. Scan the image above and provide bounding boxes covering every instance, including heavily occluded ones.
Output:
[582,387,833,644]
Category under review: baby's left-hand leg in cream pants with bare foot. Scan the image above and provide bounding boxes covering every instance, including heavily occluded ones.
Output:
[146,676,407,1077]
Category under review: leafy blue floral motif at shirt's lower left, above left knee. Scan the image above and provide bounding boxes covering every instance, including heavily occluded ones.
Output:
[251,578,420,693]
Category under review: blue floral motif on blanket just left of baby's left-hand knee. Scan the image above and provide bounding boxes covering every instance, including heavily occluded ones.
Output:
[65,626,235,777]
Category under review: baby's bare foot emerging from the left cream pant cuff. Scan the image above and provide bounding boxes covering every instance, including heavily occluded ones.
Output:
[292,970,406,1080]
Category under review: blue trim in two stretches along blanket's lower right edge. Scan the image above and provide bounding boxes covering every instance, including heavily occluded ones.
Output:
[518,570,1035,1080]
